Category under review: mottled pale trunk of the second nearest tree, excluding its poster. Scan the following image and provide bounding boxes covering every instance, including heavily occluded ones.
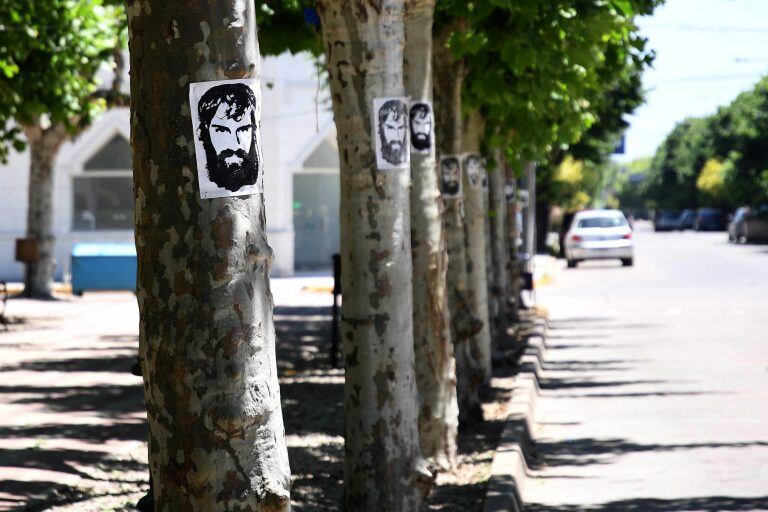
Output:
[318,0,432,512]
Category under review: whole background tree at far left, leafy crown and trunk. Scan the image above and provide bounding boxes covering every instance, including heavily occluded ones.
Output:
[0,0,127,298]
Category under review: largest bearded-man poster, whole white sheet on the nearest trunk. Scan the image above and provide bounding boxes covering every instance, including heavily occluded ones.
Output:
[189,78,264,199]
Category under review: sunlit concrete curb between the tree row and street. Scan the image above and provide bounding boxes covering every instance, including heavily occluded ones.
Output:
[483,317,547,512]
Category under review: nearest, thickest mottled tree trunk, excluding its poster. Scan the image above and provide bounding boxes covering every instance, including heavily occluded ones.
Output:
[127,0,290,512]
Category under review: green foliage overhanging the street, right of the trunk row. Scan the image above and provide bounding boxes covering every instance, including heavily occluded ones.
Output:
[436,0,660,166]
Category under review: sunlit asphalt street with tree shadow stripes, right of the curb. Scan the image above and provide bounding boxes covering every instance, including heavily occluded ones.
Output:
[523,227,768,512]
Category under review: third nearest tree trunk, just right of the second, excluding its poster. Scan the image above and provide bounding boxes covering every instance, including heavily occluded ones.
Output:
[405,0,459,468]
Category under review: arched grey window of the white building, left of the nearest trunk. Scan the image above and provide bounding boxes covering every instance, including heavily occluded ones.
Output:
[72,135,133,231]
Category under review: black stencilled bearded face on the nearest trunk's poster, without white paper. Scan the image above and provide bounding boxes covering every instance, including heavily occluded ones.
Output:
[197,83,261,192]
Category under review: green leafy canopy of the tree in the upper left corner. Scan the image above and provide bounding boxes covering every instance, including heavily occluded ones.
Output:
[0,0,125,159]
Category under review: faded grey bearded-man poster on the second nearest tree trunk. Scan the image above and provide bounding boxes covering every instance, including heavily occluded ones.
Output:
[373,98,411,170]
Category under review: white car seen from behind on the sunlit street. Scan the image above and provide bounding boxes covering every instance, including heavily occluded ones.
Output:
[565,210,634,268]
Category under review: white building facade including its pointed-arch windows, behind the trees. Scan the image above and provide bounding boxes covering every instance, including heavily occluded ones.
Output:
[0,54,339,281]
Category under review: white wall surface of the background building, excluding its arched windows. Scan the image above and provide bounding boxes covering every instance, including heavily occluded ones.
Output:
[0,54,332,281]
